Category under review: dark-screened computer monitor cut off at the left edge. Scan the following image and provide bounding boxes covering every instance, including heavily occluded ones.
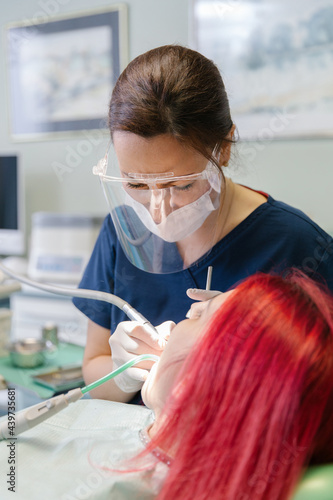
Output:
[0,154,25,256]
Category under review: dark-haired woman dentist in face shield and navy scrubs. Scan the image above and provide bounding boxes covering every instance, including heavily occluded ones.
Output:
[74,45,333,402]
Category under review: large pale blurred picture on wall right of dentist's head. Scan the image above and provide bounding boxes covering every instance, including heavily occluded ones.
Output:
[191,0,333,140]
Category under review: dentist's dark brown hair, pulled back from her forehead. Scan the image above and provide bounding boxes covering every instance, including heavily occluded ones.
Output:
[109,45,233,164]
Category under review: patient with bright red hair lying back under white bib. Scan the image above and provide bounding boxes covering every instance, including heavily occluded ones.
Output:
[0,271,333,500]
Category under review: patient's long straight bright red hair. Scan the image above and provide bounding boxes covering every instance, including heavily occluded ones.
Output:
[151,271,333,500]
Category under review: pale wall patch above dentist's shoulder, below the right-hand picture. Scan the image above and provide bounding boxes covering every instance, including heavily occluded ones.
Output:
[231,139,333,229]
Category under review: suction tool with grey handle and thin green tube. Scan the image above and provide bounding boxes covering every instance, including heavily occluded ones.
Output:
[0,354,159,440]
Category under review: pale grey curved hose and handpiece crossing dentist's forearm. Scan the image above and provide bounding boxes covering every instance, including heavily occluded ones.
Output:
[0,262,160,336]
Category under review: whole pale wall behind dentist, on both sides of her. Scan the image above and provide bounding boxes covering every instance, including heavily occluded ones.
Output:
[0,0,333,256]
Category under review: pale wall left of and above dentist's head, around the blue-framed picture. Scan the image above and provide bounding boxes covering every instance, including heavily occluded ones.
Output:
[0,0,188,249]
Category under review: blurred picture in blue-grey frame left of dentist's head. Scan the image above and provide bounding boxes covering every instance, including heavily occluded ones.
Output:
[6,4,128,141]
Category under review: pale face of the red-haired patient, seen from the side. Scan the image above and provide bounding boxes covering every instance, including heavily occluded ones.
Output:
[142,292,232,417]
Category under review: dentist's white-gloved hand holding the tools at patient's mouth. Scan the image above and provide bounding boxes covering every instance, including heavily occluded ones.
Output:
[109,321,175,392]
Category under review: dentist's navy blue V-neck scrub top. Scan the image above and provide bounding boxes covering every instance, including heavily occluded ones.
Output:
[73,196,333,333]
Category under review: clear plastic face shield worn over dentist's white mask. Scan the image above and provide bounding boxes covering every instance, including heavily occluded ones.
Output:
[93,145,223,274]
